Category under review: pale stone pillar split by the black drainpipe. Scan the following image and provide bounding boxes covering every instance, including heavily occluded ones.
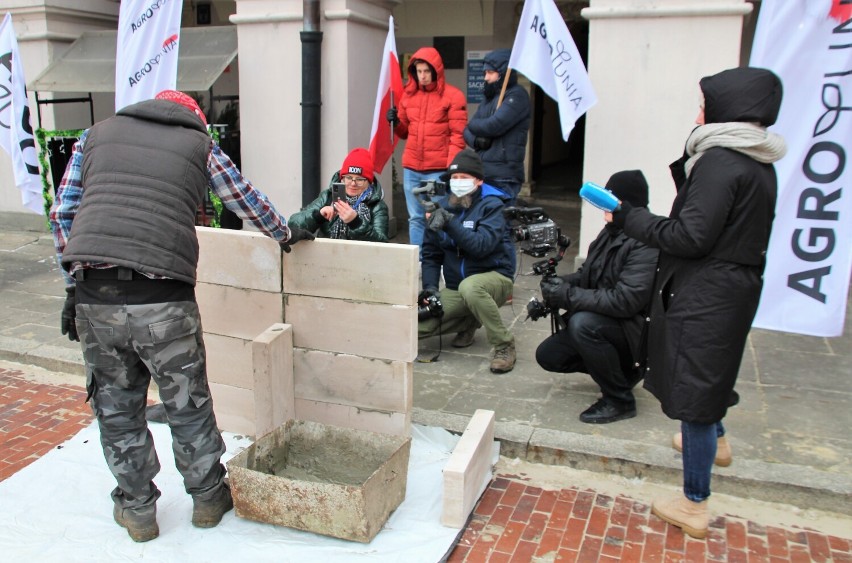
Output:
[231,0,397,224]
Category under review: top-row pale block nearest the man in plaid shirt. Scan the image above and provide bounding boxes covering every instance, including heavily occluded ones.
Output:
[195,227,282,292]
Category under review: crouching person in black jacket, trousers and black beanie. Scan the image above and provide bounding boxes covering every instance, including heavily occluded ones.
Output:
[536,170,658,424]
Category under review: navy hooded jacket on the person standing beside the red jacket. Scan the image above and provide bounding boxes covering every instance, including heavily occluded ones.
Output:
[464,49,530,183]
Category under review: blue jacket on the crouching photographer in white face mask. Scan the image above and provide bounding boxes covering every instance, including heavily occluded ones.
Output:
[422,184,515,289]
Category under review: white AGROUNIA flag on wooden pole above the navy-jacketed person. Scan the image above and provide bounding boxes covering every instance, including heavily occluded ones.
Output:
[509,0,598,141]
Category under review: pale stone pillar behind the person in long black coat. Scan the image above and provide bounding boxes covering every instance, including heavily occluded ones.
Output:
[580,0,752,256]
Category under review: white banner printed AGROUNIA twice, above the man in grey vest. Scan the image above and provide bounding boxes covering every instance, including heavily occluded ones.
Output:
[115,0,183,111]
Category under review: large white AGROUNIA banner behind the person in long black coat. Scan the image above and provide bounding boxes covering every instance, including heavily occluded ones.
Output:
[750,0,852,336]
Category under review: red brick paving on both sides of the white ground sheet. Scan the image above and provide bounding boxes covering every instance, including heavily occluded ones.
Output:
[0,368,852,563]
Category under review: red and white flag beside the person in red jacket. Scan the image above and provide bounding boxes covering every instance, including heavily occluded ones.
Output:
[370,16,402,172]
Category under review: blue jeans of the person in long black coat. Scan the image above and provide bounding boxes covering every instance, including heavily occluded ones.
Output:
[680,421,725,502]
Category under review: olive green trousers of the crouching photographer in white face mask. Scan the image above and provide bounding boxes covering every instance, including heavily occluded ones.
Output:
[417,272,514,348]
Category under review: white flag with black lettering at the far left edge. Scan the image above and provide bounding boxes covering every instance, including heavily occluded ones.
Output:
[0,13,44,214]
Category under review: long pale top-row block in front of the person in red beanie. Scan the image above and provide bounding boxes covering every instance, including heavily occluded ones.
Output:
[283,239,419,305]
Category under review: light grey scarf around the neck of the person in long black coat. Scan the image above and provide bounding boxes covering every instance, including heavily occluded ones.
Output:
[685,122,787,177]
